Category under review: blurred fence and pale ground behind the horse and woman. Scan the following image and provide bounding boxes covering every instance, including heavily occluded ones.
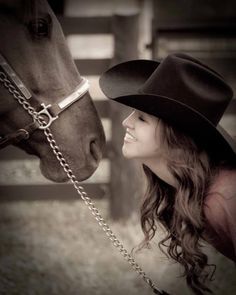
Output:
[0,0,236,295]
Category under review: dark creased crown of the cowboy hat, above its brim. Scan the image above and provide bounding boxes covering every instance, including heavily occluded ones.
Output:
[139,53,233,126]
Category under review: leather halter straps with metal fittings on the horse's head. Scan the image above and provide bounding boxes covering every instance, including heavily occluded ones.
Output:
[0,53,89,149]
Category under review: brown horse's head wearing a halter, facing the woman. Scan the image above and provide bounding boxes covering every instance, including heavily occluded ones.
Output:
[0,0,105,182]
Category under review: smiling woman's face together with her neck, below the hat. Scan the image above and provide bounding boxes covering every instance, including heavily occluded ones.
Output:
[122,110,177,187]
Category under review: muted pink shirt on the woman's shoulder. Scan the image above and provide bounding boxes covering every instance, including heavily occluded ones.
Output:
[204,170,236,262]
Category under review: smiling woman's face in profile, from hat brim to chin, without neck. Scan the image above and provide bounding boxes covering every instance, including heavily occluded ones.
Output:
[122,110,162,164]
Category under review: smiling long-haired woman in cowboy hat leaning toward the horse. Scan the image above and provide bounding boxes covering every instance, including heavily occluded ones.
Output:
[100,53,236,294]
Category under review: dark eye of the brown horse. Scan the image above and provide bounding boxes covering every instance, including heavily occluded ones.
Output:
[28,17,52,39]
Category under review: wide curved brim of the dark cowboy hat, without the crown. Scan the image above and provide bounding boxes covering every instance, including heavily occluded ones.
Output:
[99,60,236,160]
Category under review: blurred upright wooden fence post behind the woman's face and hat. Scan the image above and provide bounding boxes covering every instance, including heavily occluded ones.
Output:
[109,13,143,220]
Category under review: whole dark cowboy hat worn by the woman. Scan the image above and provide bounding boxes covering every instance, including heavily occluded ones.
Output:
[99,53,236,160]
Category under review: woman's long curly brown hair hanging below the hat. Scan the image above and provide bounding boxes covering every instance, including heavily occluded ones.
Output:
[140,120,223,295]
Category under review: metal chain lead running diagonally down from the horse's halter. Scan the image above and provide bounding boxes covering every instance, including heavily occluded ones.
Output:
[0,72,163,294]
